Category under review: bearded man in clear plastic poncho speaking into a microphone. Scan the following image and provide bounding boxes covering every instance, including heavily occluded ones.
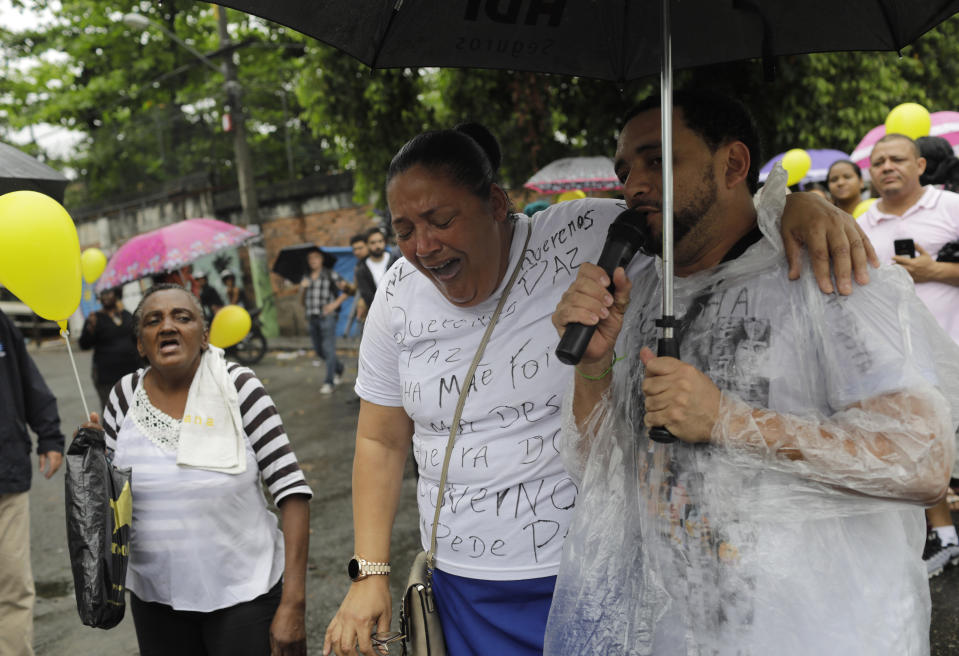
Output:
[546,93,959,656]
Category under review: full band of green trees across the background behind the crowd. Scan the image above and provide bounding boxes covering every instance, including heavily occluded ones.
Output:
[0,0,959,210]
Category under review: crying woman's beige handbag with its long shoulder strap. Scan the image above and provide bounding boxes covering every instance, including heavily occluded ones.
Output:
[400,226,533,656]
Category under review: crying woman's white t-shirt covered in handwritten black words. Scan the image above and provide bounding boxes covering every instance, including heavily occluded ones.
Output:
[356,199,651,580]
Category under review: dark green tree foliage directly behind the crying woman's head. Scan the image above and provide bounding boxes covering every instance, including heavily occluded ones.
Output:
[297,62,649,203]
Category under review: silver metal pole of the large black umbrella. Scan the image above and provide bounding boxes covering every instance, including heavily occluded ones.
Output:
[649,0,679,442]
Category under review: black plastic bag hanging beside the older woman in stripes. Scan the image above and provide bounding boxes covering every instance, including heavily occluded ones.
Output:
[65,428,133,629]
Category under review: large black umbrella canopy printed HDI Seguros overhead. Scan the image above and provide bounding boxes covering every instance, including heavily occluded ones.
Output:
[214,0,959,81]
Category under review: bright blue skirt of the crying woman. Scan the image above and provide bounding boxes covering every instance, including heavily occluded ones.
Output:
[433,570,556,656]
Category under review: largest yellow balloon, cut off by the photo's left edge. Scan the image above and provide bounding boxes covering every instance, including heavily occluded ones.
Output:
[0,191,83,330]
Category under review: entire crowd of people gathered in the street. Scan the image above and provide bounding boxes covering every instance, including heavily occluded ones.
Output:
[0,91,959,656]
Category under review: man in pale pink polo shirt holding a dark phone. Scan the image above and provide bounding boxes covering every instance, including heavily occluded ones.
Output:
[859,134,959,577]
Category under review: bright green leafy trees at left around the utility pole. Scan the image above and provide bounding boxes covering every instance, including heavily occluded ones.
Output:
[0,0,330,204]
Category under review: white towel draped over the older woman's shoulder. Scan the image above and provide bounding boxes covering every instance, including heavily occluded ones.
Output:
[176,346,246,474]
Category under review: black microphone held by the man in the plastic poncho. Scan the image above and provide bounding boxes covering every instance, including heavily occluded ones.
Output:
[556,210,646,365]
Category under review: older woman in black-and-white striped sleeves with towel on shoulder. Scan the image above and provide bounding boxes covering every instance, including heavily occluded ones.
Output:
[93,285,312,656]
